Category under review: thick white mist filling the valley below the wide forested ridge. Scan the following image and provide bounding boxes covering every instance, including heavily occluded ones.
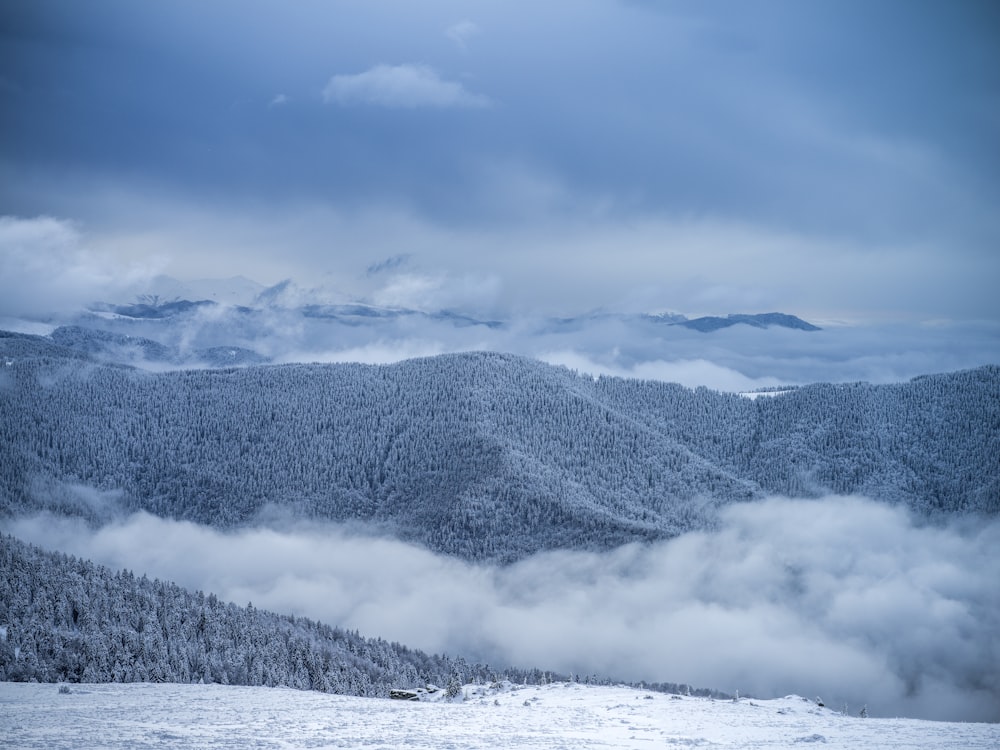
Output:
[6,497,1000,721]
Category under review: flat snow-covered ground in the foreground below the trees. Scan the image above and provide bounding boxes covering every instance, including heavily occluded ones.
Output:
[0,683,1000,750]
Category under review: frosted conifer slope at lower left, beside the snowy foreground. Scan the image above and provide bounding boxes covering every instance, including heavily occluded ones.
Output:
[0,536,500,696]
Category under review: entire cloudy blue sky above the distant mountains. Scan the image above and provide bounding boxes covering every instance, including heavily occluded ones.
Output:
[0,0,1000,322]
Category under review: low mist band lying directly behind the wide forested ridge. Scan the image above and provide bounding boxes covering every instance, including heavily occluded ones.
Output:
[41,282,1000,391]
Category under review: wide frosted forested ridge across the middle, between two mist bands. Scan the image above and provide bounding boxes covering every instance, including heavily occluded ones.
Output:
[0,336,1000,561]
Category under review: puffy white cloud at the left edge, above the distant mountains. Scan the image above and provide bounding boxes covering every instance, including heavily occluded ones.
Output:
[0,216,157,316]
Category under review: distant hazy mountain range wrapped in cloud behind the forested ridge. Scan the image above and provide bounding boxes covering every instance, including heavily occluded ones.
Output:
[4,276,836,378]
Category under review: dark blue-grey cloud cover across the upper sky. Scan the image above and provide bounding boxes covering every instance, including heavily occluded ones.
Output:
[0,0,1000,250]
